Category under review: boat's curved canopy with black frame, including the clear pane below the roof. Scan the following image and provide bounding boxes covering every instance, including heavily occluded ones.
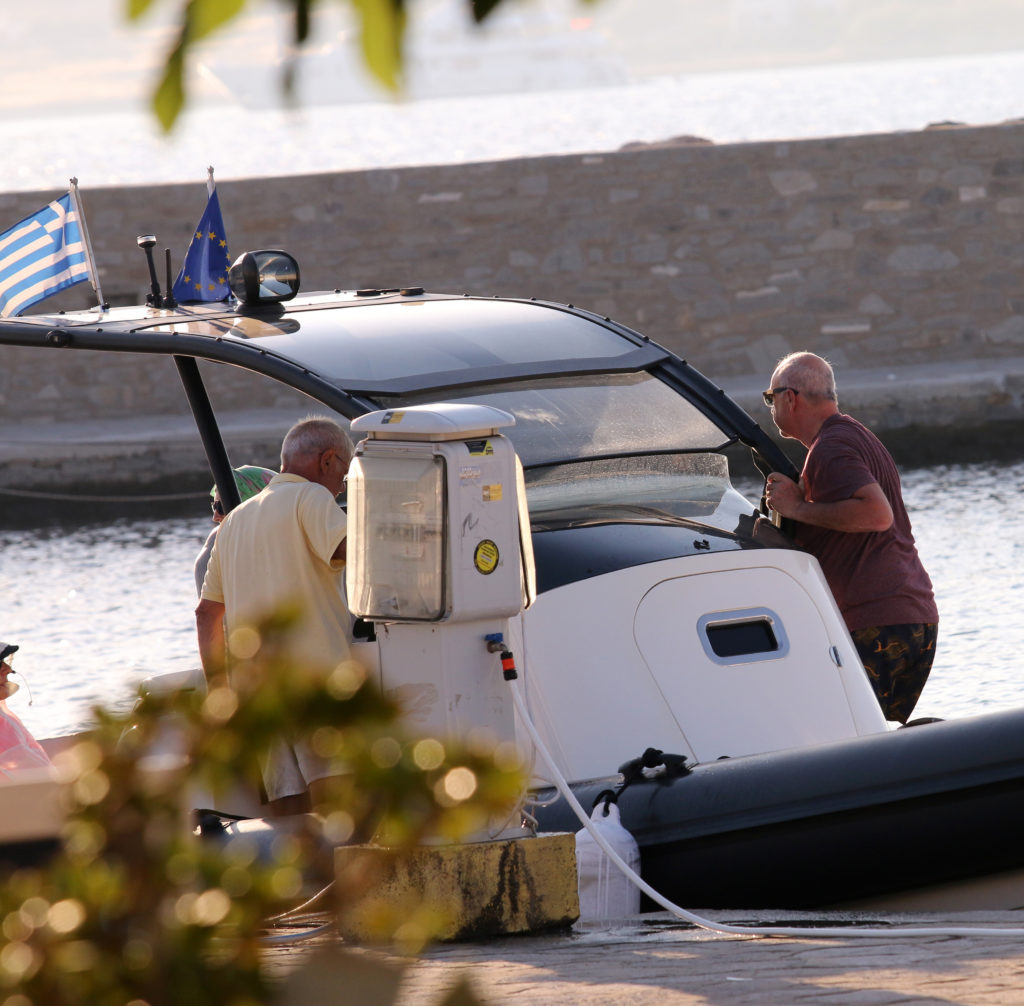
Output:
[0,288,792,504]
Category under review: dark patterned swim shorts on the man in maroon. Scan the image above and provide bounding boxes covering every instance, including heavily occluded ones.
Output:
[850,622,939,723]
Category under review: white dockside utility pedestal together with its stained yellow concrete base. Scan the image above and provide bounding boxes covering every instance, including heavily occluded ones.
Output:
[336,403,580,938]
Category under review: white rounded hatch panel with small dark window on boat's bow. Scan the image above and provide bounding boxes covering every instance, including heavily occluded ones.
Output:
[635,552,856,761]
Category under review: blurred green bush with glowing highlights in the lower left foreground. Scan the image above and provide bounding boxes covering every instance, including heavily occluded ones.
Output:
[0,618,523,1006]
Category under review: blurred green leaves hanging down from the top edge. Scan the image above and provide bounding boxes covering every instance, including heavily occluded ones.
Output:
[127,0,595,131]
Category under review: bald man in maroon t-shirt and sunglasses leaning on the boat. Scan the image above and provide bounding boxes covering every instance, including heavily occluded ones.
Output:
[764,352,939,723]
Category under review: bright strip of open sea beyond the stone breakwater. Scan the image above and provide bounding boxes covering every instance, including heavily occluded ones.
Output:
[6,51,1024,194]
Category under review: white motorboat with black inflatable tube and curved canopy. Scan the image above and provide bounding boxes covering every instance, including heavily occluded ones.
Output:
[0,251,1024,909]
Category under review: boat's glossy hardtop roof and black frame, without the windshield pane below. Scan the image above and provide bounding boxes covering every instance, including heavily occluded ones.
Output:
[0,289,795,509]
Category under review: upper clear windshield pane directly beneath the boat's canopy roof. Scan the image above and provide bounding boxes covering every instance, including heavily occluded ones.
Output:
[391,372,729,468]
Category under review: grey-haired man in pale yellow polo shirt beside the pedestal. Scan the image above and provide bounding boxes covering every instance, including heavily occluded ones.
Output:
[196,417,351,814]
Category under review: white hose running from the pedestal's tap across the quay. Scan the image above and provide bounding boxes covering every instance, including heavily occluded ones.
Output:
[509,678,1024,939]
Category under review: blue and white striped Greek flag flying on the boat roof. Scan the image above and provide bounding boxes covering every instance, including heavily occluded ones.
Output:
[0,193,89,318]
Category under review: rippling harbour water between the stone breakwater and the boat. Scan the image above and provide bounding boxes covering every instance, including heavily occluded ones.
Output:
[0,462,1024,737]
